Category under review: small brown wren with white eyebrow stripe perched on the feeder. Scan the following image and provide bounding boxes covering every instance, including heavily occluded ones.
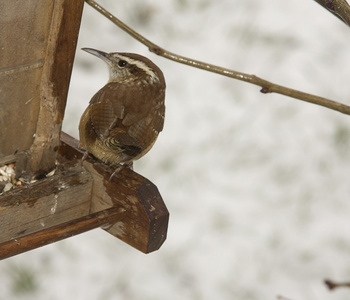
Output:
[79,48,165,176]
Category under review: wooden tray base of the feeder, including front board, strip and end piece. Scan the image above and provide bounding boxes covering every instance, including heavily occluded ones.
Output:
[0,132,169,259]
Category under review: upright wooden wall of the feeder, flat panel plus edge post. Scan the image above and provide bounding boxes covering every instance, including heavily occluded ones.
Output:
[0,0,84,178]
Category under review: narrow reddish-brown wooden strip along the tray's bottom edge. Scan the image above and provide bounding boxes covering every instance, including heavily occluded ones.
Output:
[0,207,124,260]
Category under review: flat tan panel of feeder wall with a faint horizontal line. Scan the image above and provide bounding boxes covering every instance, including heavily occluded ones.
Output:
[0,0,53,157]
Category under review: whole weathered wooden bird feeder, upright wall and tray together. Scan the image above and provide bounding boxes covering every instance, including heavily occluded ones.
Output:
[0,0,169,259]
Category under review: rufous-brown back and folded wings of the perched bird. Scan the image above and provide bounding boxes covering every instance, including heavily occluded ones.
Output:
[90,83,165,156]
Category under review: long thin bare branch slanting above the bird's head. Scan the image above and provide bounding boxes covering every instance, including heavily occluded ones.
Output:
[85,0,350,115]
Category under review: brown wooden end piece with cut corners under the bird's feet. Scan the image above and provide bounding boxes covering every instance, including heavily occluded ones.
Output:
[60,132,169,253]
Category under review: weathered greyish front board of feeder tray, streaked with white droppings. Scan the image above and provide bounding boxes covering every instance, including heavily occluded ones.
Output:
[0,164,92,243]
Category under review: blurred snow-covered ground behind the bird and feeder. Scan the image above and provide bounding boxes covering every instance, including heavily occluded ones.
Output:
[0,0,350,300]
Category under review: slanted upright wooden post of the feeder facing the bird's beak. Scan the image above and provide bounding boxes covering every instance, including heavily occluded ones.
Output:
[24,0,84,178]
